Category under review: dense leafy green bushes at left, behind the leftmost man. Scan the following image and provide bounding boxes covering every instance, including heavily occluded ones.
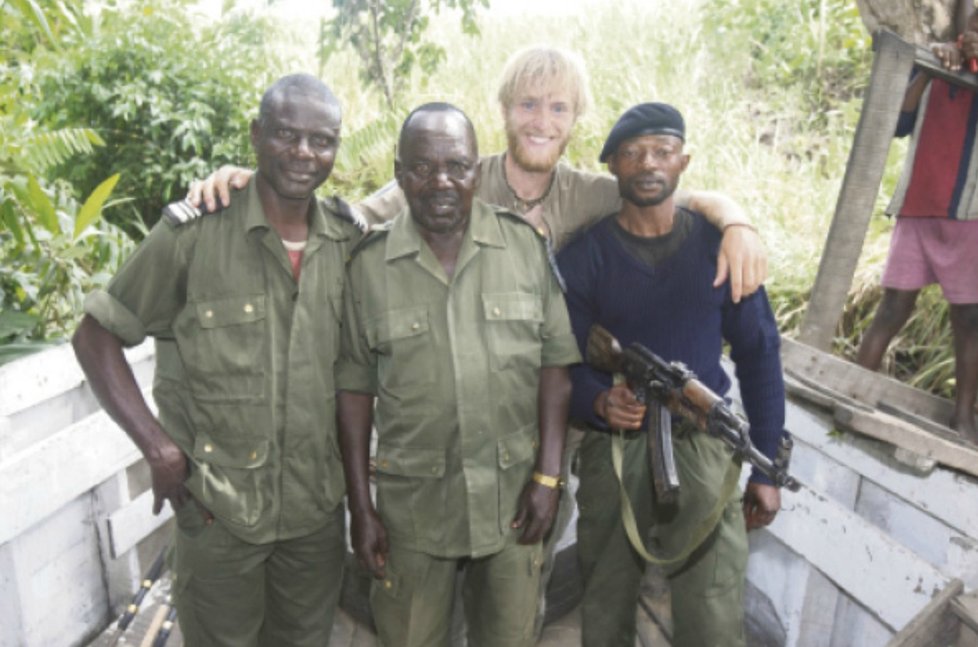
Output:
[0,0,290,363]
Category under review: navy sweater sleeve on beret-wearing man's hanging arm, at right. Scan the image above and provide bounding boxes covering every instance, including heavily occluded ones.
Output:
[723,287,785,485]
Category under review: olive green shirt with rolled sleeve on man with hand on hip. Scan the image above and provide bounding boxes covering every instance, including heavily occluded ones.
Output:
[85,182,360,543]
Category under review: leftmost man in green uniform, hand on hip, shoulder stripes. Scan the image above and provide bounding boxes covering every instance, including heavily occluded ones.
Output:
[73,75,359,647]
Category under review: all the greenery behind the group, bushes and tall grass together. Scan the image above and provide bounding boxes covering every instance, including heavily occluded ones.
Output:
[0,0,953,394]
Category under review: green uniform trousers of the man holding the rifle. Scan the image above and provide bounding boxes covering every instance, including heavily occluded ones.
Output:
[577,420,747,647]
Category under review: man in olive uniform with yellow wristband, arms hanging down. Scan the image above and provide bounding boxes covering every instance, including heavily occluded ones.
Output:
[336,104,580,647]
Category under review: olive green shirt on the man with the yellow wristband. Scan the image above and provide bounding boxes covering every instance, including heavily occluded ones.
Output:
[336,200,580,557]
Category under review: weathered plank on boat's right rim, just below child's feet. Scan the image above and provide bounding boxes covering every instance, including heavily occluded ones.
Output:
[835,404,978,476]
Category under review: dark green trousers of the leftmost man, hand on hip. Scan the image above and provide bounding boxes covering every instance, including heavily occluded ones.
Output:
[171,502,346,647]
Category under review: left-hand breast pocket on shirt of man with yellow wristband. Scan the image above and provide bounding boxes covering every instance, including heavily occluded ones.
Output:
[366,306,435,393]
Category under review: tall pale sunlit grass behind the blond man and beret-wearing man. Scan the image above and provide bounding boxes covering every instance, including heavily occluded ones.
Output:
[264,0,953,395]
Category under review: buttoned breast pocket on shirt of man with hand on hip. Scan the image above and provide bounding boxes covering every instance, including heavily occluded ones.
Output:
[184,294,268,402]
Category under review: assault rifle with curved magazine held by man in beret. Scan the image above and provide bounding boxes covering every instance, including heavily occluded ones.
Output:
[585,325,801,503]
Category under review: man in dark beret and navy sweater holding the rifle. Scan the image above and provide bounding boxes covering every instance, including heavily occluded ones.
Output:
[558,103,784,647]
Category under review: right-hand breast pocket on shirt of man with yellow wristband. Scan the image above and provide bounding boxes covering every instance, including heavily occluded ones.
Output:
[482,292,543,370]
